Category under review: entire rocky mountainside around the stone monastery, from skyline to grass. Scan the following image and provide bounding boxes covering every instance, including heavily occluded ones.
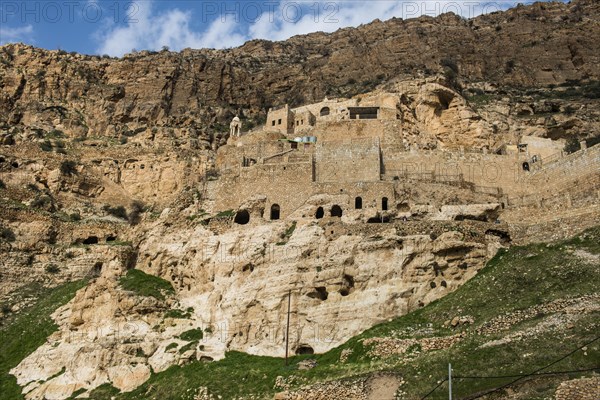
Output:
[0,0,600,399]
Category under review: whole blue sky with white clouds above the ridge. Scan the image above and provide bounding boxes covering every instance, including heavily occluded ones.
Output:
[0,0,568,56]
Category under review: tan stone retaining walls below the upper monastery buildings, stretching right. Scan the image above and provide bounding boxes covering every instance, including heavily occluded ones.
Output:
[208,120,600,244]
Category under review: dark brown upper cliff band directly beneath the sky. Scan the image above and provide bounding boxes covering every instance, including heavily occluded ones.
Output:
[0,0,600,148]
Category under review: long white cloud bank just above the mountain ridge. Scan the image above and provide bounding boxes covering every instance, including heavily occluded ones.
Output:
[96,0,544,56]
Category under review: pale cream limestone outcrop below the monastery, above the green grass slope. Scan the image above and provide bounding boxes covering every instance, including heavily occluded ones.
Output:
[12,205,499,399]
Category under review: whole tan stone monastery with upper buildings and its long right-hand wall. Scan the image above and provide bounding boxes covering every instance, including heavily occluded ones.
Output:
[217,94,600,230]
